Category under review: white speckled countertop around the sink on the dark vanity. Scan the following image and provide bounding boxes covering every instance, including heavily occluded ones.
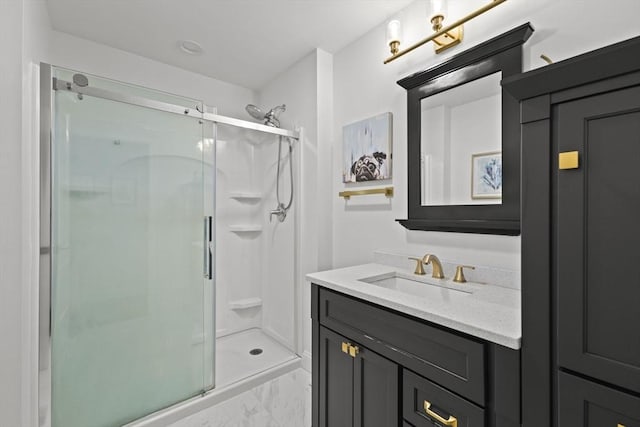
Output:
[306,264,522,350]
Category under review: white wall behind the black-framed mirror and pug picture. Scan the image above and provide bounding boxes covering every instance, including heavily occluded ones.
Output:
[332,0,640,270]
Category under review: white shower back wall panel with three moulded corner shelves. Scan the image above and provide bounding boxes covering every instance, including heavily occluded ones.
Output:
[215,124,266,336]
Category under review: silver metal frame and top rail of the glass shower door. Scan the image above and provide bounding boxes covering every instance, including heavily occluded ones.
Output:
[37,62,302,427]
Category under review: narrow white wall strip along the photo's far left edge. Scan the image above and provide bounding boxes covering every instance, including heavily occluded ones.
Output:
[0,1,23,426]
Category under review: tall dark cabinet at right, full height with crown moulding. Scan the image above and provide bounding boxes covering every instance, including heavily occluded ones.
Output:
[503,37,640,427]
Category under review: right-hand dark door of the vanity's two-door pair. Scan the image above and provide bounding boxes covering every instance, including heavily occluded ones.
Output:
[353,348,400,427]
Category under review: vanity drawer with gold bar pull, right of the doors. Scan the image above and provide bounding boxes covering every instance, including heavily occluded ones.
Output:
[402,369,485,427]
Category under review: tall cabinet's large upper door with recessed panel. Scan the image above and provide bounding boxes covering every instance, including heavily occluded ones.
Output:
[556,86,640,393]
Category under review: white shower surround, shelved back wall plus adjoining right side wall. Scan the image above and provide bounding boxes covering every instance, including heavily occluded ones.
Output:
[216,125,298,350]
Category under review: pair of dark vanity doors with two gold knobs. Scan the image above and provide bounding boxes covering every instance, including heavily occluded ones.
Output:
[319,327,400,427]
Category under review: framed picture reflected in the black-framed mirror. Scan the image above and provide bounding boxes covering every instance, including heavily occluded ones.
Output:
[471,151,502,200]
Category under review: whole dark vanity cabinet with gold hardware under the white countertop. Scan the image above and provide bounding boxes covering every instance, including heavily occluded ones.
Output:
[312,285,520,427]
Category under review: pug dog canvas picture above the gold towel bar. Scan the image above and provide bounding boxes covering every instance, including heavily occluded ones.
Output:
[342,112,393,183]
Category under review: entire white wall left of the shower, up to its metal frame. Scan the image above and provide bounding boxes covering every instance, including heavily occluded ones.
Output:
[0,0,48,426]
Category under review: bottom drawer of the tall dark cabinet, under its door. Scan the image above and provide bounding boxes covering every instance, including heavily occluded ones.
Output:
[558,372,640,427]
